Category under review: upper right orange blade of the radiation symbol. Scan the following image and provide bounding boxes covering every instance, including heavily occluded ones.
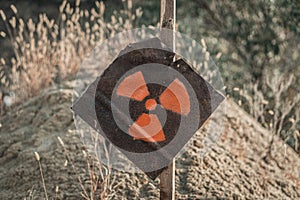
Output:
[159,79,190,115]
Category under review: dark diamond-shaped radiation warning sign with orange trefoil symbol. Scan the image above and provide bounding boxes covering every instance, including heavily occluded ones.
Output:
[72,38,224,179]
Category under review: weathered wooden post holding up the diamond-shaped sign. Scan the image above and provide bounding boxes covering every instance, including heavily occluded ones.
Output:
[160,0,176,200]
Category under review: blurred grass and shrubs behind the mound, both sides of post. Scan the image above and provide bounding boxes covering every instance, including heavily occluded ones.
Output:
[0,0,300,152]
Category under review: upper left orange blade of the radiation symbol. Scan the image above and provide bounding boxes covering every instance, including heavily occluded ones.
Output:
[117,72,149,101]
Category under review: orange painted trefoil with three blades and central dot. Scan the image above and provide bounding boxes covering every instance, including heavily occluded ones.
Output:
[117,71,191,142]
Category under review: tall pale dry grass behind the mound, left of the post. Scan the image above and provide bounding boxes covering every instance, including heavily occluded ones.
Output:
[0,0,142,101]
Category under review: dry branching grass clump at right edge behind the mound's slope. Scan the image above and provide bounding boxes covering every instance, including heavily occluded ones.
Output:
[233,69,300,154]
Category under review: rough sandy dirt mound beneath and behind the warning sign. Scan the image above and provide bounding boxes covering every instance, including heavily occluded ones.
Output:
[0,82,300,199]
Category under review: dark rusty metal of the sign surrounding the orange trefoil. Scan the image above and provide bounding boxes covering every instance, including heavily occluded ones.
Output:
[72,38,224,179]
